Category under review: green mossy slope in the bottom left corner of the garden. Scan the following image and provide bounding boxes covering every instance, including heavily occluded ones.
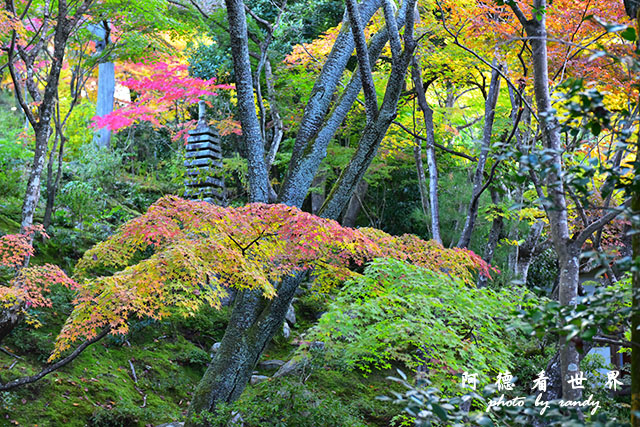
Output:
[0,337,203,427]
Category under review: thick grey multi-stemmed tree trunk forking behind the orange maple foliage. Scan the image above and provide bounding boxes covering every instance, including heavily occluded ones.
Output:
[186,0,415,427]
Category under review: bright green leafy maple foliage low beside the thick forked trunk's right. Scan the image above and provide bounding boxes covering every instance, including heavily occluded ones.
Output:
[307,259,534,392]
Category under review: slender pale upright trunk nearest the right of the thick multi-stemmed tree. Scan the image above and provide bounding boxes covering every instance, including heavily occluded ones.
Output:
[411,57,442,244]
